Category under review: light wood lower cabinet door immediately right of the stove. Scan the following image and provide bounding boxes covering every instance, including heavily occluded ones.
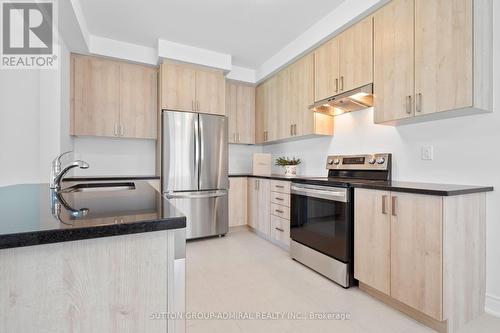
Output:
[354,189,391,295]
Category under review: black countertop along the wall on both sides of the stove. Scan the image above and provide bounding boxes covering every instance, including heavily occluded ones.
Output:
[229,173,493,196]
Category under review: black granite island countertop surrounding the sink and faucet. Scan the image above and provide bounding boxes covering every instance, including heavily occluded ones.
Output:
[0,178,186,249]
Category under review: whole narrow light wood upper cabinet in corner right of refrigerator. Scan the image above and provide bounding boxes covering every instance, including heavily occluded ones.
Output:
[226,80,256,144]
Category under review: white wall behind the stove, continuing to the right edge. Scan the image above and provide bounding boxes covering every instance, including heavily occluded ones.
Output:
[263,1,500,315]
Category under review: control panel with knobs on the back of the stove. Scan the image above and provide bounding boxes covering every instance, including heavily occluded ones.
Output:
[326,153,391,170]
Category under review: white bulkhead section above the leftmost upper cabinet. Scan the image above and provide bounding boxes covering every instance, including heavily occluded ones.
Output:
[89,35,158,65]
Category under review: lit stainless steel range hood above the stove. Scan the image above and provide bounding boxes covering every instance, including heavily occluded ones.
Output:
[309,83,373,116]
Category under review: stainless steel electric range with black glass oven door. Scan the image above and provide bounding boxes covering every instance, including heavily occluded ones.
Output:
[290,153,392,288]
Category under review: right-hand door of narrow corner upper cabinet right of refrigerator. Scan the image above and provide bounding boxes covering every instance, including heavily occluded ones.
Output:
[236,84,255,144]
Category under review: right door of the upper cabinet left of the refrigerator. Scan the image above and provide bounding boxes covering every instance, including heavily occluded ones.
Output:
[120,63,158,139]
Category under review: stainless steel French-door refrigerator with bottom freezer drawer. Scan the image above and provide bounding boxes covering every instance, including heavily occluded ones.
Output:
[162,110,229,239]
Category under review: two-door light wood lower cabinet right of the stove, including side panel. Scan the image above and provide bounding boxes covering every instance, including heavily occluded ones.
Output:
[354,189,485,332]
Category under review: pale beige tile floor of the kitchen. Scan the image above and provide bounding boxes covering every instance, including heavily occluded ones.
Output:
[186,229,500,333]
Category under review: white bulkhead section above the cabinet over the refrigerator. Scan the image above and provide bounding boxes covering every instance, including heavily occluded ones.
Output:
[158,39,232,71]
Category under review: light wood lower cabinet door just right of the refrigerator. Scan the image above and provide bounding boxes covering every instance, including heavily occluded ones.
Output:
[228,177,247,227]
